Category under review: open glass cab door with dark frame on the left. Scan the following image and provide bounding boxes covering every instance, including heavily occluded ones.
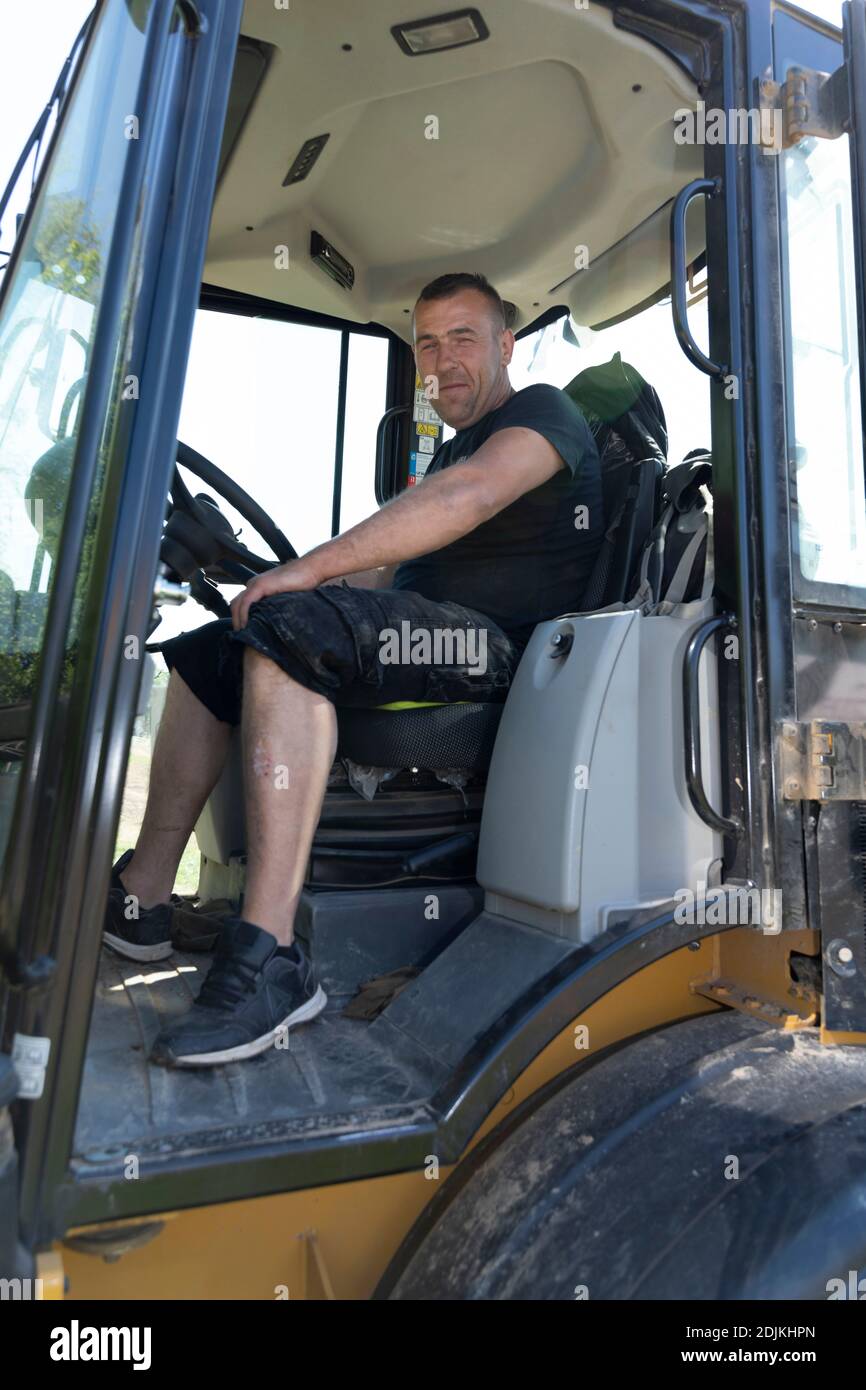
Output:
[0,0,242,1272]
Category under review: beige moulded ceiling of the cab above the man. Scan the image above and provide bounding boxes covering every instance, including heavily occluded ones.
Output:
[204,0,701,338]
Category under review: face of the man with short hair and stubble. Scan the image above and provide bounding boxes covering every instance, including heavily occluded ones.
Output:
[414,289,514,430]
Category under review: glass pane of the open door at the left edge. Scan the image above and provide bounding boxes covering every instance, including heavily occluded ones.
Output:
[0,0,150,847]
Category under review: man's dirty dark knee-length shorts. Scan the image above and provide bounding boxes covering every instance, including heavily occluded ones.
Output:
[158,584,521,724]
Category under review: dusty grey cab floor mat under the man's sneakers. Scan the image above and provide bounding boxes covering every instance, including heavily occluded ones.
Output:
[74,951,448,1163]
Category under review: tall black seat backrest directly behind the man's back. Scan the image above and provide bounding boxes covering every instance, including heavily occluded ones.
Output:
[564,353,667,613]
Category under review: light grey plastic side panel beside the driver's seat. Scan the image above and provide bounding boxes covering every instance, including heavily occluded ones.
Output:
[478,603,720,941]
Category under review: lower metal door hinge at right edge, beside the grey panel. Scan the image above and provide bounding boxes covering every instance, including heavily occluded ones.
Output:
[780,719,866,801]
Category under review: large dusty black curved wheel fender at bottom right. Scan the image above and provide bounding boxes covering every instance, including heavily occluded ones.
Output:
[375,1011,866,1301]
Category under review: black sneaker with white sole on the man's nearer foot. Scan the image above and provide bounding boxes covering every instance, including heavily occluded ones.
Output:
[150,917,328,1066]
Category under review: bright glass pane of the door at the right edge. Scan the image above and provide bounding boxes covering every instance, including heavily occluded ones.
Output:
[774,14,866,607]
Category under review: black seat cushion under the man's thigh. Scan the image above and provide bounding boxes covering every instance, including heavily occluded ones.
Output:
[336,702,505,771]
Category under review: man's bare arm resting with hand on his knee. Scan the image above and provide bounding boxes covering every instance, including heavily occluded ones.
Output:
[232,427,564,628]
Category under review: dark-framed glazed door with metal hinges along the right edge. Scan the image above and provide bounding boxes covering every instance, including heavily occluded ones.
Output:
[773,0,866,1034]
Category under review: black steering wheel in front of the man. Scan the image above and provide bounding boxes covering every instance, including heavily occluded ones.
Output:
[160,439,297,617]
